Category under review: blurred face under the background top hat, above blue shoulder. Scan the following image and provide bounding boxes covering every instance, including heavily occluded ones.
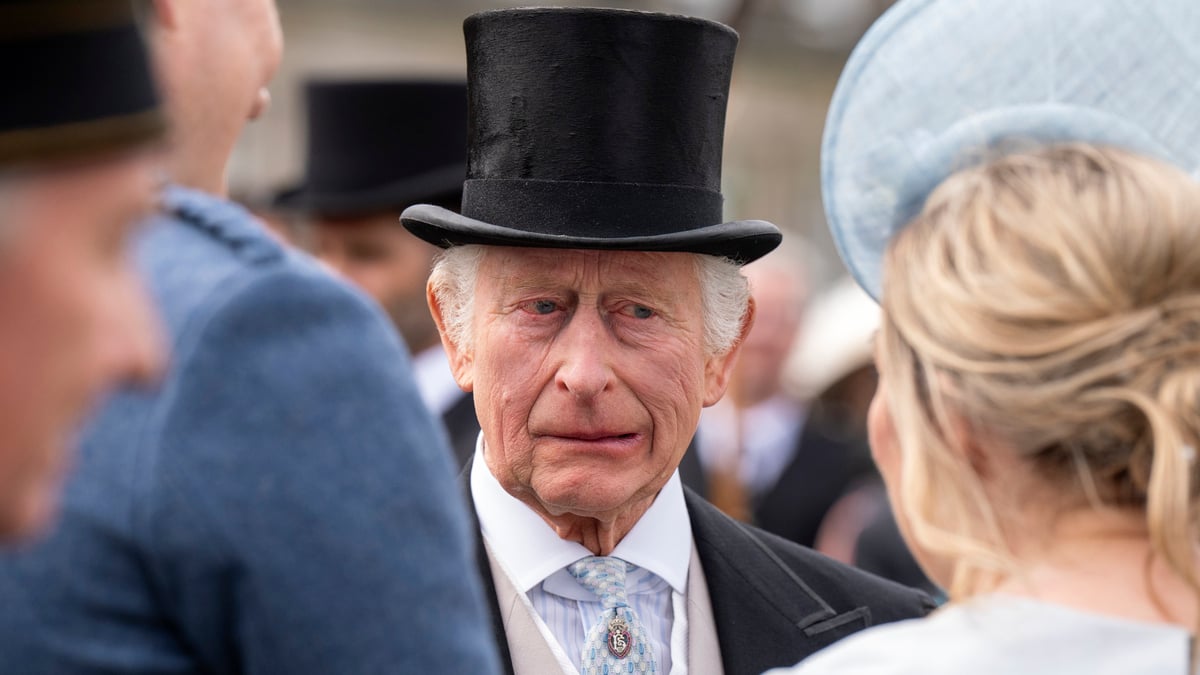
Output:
[314,214,438,351]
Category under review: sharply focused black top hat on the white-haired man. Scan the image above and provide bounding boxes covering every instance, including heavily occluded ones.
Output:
[401,7,780,263]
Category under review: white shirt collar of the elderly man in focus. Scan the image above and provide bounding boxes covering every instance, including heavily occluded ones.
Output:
[470,434,691,593]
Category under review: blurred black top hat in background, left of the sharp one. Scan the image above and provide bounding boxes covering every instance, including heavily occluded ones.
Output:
[275,80,467,216]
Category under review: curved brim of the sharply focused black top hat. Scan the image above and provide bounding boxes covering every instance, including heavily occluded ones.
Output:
[400,204,782,264]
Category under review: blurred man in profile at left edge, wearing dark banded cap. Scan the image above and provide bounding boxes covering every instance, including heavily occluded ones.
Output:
[0,0,163,539]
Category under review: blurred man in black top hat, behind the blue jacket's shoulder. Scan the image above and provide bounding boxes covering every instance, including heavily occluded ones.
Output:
[275,79,479,456]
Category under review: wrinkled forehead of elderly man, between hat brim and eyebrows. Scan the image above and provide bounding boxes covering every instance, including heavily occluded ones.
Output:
[480,246,700,291]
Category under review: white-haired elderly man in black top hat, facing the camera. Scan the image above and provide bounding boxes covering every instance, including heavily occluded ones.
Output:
[402,8,929,675]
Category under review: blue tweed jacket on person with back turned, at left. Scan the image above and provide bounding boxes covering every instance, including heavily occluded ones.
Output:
[0,187,498,675]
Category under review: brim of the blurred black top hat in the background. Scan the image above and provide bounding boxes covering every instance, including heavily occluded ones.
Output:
[271,165,467,217]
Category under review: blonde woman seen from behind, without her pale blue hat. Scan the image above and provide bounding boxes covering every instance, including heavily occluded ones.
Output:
[772,144,1200,674]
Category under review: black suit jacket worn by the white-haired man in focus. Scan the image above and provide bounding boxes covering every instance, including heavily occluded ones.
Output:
[462,462,934,675]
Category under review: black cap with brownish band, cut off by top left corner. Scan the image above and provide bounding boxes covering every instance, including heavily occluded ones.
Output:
[0,0,166,167]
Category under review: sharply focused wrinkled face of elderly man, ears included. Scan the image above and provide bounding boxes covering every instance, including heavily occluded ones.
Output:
[450,247,733,520]
